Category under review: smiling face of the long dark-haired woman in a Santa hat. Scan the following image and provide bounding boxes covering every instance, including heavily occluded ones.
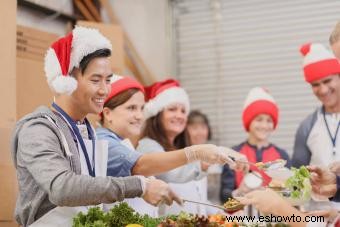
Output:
[161,103,187,140]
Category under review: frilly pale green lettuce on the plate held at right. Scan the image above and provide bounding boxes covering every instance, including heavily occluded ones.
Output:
[285,166,312,200]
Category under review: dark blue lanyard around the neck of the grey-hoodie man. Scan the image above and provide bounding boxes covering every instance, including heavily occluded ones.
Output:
[52,103,96,177]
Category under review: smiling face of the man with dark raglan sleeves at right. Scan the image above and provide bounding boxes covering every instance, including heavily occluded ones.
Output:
[311,75,340,112]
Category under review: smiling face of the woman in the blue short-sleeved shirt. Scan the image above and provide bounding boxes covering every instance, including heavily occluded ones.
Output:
[104,91,145,139]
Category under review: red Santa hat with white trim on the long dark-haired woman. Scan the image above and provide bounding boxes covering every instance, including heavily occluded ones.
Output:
[144,79,190,119]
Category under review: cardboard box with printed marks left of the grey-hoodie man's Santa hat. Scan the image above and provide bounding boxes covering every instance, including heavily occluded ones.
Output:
[16,25,58,119]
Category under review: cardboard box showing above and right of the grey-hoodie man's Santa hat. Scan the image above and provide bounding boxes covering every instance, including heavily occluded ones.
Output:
[77,21,124,74]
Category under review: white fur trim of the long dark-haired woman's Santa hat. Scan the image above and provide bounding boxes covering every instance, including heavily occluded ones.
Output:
[144,87,190,119]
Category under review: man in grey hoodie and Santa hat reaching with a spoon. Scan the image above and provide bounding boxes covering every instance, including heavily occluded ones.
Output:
[12,27,181,226]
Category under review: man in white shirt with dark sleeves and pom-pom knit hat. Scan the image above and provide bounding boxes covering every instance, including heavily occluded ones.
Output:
[292,43,340,167]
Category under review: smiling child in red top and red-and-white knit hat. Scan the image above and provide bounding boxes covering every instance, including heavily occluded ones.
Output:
[220,87,290,201]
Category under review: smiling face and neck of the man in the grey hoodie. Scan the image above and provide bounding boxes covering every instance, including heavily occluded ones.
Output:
[71,57,112,115]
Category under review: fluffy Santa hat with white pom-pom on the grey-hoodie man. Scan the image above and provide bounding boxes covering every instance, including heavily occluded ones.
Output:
[45,26,112,95]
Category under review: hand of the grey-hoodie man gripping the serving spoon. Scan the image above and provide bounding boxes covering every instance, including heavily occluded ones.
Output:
[143,178,183,206]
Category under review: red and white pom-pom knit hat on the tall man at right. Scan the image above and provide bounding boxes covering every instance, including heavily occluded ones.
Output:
[300,43,340,83]
